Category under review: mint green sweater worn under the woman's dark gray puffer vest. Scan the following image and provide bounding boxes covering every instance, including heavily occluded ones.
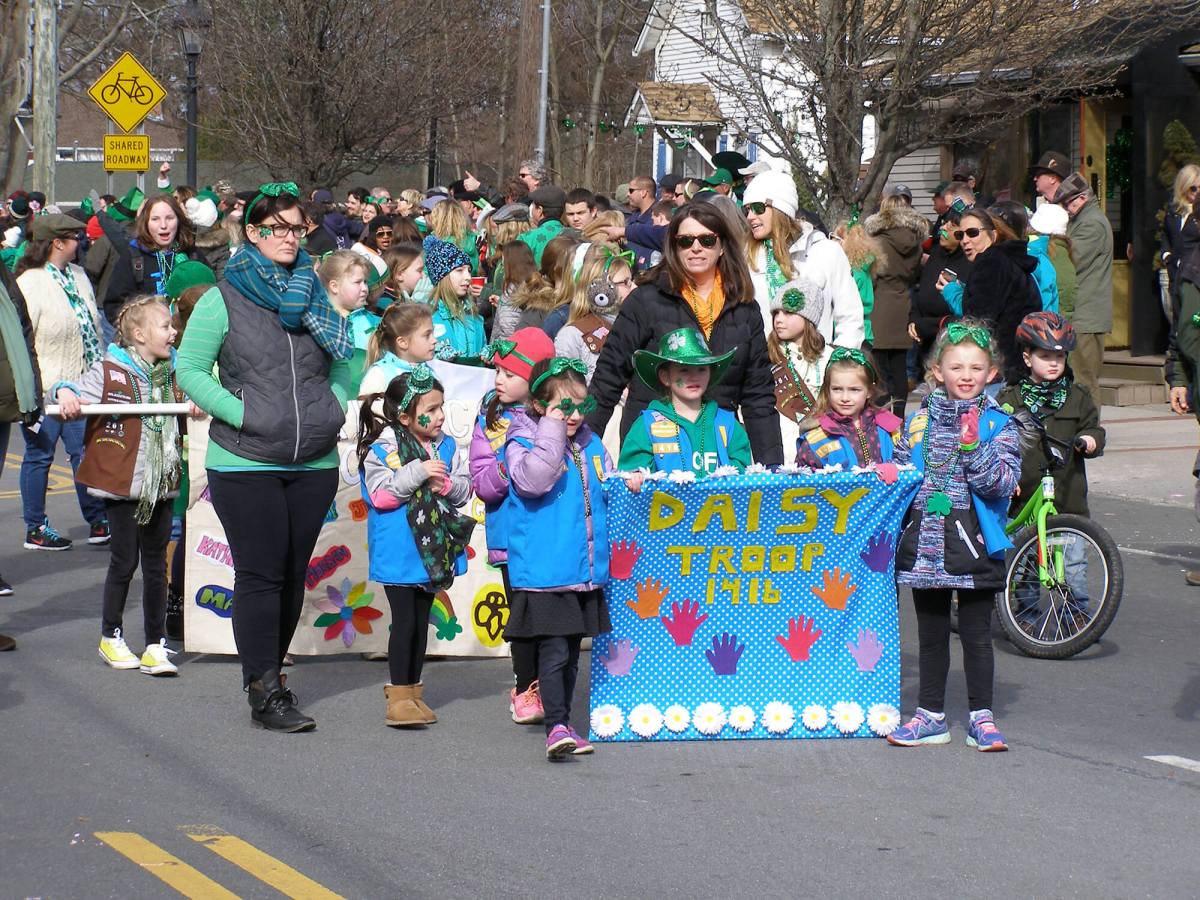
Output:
[175,288,353,472]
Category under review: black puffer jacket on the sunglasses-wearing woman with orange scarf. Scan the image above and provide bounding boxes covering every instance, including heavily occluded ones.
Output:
[588,274,784,466]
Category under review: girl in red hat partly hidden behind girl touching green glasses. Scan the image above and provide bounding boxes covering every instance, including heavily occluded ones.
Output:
[470,326,554,725]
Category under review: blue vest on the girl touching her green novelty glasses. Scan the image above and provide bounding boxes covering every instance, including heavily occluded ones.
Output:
[505,434,608,589]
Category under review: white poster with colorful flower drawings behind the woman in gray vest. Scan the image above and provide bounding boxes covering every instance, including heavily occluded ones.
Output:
[184,361,509,656]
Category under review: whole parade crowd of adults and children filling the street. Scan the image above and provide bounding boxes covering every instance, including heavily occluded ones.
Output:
[0,152,1200,758]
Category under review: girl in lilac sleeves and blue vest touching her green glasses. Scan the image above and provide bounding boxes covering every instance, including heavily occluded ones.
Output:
[504,358,612,760]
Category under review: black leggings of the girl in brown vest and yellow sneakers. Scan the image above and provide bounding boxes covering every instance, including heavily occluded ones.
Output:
[100,500,172,646]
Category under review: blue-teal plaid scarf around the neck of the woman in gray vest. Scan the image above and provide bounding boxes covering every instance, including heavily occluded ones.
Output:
[224,244,354,359]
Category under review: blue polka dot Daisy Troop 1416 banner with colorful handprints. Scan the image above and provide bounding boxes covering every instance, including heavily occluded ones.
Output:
[590,466,920,742]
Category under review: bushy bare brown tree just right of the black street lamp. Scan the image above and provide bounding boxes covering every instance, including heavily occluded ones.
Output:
[203,0,505,185]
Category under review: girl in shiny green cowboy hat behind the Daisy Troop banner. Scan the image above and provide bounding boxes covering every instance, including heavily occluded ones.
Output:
[620,328,751,480]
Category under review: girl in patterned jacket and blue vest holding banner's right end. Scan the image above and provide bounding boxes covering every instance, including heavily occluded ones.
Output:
[888,319,1021,751]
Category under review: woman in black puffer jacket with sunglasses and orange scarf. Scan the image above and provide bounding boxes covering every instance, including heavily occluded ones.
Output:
[588,203,784,466]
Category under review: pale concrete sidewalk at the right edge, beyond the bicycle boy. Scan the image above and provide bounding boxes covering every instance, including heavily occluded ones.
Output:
[1087,403,1200,508]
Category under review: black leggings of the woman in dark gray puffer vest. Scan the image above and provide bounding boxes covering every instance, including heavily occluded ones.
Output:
[209,469,337,685]
